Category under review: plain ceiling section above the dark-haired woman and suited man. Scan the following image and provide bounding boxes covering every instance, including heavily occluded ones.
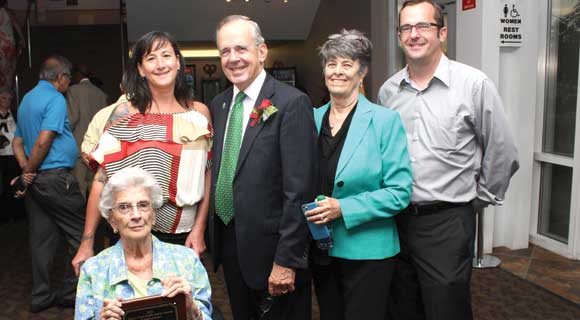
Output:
[125,0,320,42]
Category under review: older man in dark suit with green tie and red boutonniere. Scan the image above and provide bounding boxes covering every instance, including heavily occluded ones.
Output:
[209,16,317,319]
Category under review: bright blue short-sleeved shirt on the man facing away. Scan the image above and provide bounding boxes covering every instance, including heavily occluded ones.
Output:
[15,80,78,170]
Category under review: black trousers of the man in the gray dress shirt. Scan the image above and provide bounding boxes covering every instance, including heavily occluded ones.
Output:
[390,204,475,320]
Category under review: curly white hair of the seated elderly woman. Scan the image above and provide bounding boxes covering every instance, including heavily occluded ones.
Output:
[99,167,163,219]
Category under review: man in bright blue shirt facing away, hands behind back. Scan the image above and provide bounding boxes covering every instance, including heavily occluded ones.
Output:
[12,55,85,313]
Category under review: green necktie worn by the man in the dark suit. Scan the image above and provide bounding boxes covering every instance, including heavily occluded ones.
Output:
[215,91,246,225]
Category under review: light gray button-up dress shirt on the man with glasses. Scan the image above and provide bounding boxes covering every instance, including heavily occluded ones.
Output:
[378,55,519,205]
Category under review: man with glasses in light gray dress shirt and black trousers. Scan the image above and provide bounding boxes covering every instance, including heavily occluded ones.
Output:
[378,0,519,319]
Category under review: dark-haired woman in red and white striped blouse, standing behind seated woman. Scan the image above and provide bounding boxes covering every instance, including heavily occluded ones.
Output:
[73,31,212,272]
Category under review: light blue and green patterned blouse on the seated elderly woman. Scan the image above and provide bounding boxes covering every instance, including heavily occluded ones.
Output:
[75,236,212,320]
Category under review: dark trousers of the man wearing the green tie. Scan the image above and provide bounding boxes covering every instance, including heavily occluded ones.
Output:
[218,221,312,320]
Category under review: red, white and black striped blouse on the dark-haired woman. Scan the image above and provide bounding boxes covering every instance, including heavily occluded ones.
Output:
[91,110,212,233]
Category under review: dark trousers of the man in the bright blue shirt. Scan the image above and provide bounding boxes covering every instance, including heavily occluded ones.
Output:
[25,169,85,306]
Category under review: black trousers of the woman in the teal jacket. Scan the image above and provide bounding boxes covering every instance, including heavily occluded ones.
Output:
[312,258,395,320]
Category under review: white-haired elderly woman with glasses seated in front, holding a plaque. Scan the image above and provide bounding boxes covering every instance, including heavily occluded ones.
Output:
[75,168,212,320]
